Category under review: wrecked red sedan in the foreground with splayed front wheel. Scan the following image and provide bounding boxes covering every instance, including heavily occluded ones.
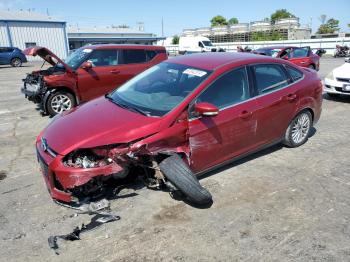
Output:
[36,53,322,204]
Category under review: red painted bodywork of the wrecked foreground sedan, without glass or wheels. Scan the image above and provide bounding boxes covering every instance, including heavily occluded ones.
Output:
[37,53,322,202]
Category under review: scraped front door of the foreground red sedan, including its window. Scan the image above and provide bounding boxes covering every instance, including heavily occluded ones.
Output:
[189,67,258,172]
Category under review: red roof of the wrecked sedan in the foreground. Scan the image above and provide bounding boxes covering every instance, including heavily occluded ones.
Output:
[167,52,281,70]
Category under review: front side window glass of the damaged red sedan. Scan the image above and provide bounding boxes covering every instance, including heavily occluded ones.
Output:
[196,68,250,109]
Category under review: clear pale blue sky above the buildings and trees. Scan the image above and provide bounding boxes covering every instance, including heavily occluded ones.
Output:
[0,0,350,36]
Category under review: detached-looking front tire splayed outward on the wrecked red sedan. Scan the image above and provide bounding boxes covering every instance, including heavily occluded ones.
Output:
[159,155,213,205]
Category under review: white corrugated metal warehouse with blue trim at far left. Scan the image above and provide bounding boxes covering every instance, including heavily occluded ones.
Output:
[0,11,68,59]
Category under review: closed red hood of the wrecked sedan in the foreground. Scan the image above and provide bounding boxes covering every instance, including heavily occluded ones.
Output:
[42,97,161,155]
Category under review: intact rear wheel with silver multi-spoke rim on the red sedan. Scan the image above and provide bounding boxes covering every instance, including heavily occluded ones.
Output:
[283,110,312,147]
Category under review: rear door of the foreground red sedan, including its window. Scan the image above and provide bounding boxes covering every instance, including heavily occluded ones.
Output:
[251,64,298,144]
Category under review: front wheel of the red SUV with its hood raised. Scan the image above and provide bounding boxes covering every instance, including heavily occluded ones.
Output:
[46,91,76,116]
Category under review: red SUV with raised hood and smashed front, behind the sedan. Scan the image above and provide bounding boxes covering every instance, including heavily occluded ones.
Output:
[21,45,167,116]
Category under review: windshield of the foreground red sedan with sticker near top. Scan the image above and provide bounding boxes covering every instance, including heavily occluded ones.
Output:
[107,62,210,116]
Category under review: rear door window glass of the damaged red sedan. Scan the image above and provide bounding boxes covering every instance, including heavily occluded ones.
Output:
[253,64,288,95]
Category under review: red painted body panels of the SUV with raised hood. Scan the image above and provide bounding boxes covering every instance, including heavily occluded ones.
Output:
[23,45,167,102]
